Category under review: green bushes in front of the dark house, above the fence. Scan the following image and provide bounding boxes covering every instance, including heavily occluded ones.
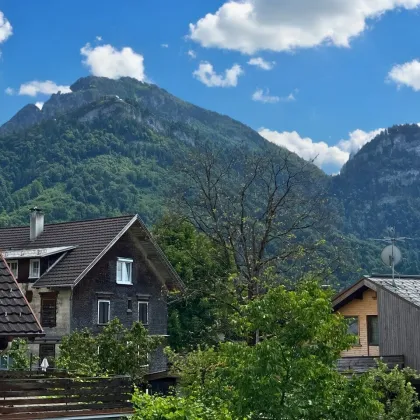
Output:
[56,318,161,380]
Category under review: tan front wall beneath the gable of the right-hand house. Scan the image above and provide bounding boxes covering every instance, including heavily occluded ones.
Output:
[339,290,379,357]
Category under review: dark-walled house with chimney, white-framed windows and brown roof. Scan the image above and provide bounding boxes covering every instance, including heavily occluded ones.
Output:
[0,208,183,373]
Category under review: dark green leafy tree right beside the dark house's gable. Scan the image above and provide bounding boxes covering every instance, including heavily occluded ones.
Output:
[153,215,235,350]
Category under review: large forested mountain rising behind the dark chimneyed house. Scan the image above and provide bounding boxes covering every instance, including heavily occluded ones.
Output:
[0,77,316,225]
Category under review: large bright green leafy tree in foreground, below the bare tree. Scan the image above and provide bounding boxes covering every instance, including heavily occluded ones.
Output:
[170,279,382,420]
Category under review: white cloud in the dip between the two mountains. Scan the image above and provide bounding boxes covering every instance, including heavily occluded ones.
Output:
[259,128,382,171]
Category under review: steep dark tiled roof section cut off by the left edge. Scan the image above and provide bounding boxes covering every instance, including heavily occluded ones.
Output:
[0,255,44,338]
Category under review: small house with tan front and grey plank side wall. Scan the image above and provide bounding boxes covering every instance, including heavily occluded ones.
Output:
[333,275,420,371]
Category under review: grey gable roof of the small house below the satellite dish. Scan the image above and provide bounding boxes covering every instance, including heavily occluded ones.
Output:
[333,275,420,310]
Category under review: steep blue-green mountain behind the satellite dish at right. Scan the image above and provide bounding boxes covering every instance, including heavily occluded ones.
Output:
[332,124,420,274]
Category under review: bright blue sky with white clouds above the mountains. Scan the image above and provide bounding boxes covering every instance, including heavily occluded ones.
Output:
[0,0,420,173]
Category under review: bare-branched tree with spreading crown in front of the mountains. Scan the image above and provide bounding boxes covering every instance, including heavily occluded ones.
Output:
[178,143,328,300]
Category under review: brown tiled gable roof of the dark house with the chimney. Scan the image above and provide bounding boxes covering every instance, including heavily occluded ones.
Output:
[0,215,183,289]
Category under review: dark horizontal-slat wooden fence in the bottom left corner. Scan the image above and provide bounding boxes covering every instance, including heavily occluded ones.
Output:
[0,371,133,420]
